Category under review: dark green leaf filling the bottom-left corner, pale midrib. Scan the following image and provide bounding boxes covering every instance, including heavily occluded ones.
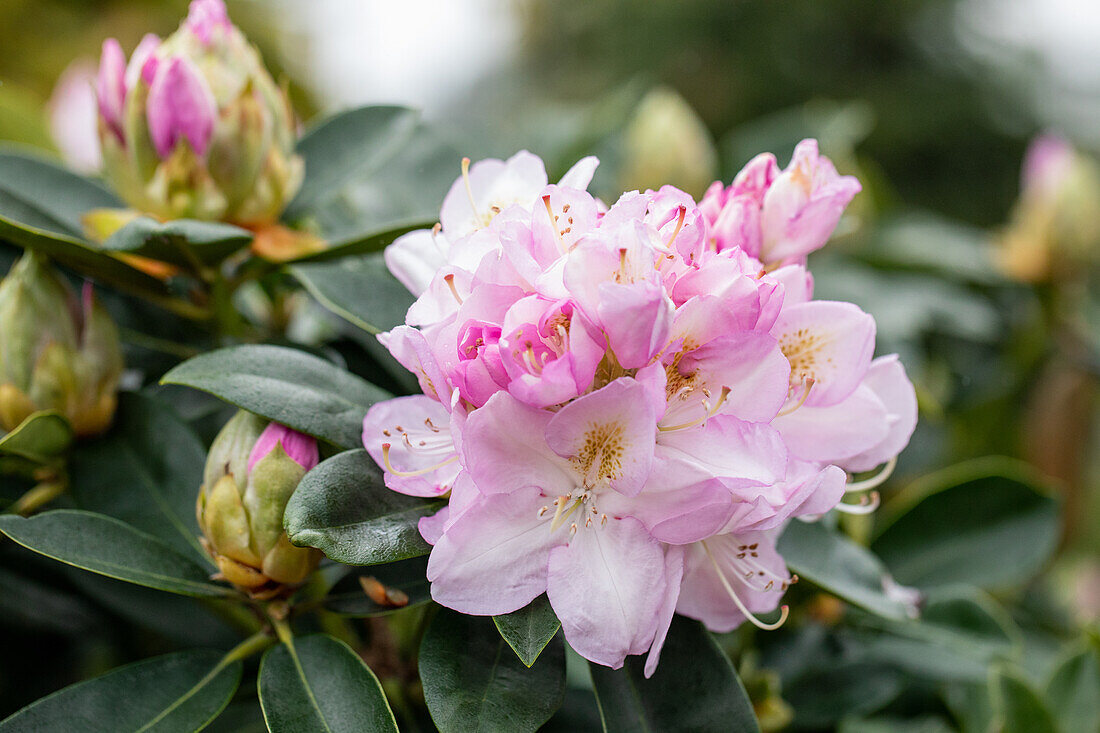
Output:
[0,649,242,733]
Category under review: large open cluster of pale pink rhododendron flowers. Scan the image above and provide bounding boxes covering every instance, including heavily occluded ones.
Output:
[363,140,916,674]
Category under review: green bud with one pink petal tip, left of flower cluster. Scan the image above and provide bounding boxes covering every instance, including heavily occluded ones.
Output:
[196,411,321,598]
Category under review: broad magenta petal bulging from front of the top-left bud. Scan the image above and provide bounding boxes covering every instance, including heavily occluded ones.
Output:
[146,57,218,158]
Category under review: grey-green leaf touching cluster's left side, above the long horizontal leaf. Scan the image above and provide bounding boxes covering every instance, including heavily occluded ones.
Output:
[289,249,415,333]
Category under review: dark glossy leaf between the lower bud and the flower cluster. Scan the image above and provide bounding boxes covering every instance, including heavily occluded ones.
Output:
[284,449,443,565]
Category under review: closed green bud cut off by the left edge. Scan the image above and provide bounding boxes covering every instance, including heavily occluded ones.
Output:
[0,251,122,436]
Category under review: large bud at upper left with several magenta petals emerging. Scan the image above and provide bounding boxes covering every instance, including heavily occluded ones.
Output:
[96,0,303,227]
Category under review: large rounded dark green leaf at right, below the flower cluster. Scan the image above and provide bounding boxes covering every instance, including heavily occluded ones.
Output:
[871,459,1060,590]
